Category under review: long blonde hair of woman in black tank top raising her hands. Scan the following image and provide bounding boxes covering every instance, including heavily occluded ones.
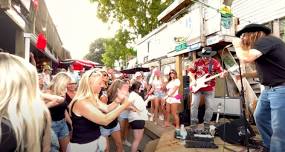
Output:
[70,69,102,105]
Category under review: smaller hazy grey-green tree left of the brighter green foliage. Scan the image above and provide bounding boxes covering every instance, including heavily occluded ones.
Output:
[84,38,107,64]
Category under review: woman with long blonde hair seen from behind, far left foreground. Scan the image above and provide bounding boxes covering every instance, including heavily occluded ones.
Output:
[0,53,50,152]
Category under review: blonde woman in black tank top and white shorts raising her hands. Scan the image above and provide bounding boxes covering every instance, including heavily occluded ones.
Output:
[68,70,130,152]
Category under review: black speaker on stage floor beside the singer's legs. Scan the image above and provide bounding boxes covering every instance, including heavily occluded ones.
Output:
[217,119,255,146]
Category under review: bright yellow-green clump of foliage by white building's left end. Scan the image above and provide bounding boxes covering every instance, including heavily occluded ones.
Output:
[102,29,136,67]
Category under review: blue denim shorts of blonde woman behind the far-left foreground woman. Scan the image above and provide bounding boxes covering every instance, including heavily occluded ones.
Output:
[51,119,69,139]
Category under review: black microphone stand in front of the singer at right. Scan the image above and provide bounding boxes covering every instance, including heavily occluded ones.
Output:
[237,58,249,152]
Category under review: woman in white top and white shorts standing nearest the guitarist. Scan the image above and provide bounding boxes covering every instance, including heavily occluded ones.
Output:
[165,69,180,129]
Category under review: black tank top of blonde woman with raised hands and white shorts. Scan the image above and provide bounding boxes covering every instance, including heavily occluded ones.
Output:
[70,101,101,144]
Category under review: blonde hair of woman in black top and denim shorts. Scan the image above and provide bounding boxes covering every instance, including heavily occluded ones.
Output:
[49,72,71,96]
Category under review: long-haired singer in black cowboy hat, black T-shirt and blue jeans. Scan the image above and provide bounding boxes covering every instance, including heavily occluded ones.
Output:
[233,24,285,152]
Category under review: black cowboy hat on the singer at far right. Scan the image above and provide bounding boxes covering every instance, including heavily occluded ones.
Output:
[236,24,271,37]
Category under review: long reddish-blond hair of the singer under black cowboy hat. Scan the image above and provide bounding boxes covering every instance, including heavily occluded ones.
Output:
[241,31,266,50]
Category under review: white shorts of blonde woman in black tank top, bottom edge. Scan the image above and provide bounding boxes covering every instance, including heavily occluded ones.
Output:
[67,136,107,152]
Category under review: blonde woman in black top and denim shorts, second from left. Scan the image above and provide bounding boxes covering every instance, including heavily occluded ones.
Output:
[47,72,71,152]
